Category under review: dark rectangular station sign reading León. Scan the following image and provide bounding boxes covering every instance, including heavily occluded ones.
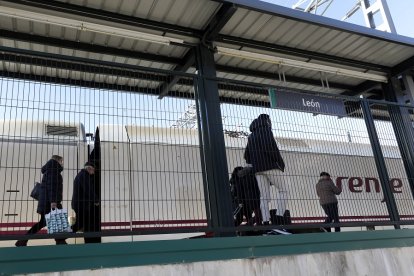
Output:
[269,88,347,117]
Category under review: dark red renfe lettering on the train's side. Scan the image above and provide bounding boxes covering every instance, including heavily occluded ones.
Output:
[336,176,402,194]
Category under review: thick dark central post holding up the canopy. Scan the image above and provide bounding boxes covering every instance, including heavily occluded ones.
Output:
[195,44,234,236]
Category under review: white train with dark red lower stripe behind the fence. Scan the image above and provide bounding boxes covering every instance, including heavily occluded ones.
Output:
[0,121,414,245]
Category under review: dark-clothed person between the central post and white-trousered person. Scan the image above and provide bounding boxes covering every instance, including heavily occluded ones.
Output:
[230,167,262,226]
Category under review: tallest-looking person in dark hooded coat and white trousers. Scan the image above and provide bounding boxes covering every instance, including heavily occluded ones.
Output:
[244,114,287,224]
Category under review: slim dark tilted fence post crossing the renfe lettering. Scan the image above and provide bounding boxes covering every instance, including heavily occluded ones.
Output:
[361,99,400,229]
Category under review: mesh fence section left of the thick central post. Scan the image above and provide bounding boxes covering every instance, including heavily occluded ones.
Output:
[0,54,207,246]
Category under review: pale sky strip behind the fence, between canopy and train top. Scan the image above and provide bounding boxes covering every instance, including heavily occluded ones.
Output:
[0,78,395,149]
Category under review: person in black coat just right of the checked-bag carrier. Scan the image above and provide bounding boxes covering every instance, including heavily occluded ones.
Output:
[72,162,100,243]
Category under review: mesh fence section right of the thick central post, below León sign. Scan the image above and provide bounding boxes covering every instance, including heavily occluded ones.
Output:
[221,86,396,233]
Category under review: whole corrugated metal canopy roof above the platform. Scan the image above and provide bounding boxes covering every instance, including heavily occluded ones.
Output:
[0,0,414,97]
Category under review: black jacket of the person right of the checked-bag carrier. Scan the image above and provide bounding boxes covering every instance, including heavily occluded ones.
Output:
[72,169,99,212]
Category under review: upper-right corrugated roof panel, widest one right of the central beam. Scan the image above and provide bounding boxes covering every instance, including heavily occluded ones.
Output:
[220,6,414,66]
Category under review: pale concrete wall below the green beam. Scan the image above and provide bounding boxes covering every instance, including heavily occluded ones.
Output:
[39,247,414,276]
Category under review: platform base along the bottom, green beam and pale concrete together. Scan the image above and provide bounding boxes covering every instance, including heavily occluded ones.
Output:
[0,229,414,276]
